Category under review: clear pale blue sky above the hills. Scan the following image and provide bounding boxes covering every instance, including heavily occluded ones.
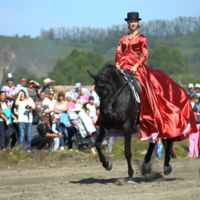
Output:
[0,0,200,37]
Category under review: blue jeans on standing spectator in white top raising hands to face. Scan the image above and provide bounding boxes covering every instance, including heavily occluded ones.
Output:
[18,122,32,150]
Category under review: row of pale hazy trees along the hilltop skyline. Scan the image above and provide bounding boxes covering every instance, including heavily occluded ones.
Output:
[40,16,200,44]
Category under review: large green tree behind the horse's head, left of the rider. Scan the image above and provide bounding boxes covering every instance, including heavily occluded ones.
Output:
[49,49,105,84]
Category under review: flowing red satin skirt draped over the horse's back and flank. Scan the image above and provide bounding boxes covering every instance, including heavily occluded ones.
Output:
[135,65,197,141]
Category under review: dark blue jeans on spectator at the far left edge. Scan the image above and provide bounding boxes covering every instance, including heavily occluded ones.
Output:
[0,121,10,150]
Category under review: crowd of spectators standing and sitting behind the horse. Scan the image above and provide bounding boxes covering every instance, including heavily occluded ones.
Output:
[0,74,200,157]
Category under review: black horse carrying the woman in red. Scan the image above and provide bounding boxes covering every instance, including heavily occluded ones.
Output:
[88,64,172,182]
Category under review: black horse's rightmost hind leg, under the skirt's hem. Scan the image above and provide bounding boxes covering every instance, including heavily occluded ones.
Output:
[163,138,172,175]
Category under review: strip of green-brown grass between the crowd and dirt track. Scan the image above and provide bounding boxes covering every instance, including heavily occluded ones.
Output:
[0,138,188,166]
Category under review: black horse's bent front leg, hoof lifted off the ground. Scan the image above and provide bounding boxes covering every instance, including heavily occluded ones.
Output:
[95,121,112,170]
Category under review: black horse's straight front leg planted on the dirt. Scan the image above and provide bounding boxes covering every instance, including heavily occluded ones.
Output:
[123,125,134,183]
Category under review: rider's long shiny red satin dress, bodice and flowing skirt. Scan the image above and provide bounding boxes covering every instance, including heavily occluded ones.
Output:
[115,33,197,141]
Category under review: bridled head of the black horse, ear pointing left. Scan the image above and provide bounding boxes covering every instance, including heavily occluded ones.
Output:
[88,64,120,99]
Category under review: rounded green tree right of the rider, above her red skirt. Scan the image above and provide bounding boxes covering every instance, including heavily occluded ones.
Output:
[148,46,189,75]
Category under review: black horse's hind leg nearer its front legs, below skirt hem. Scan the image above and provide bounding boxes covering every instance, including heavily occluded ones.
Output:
[142,142,156,175]
